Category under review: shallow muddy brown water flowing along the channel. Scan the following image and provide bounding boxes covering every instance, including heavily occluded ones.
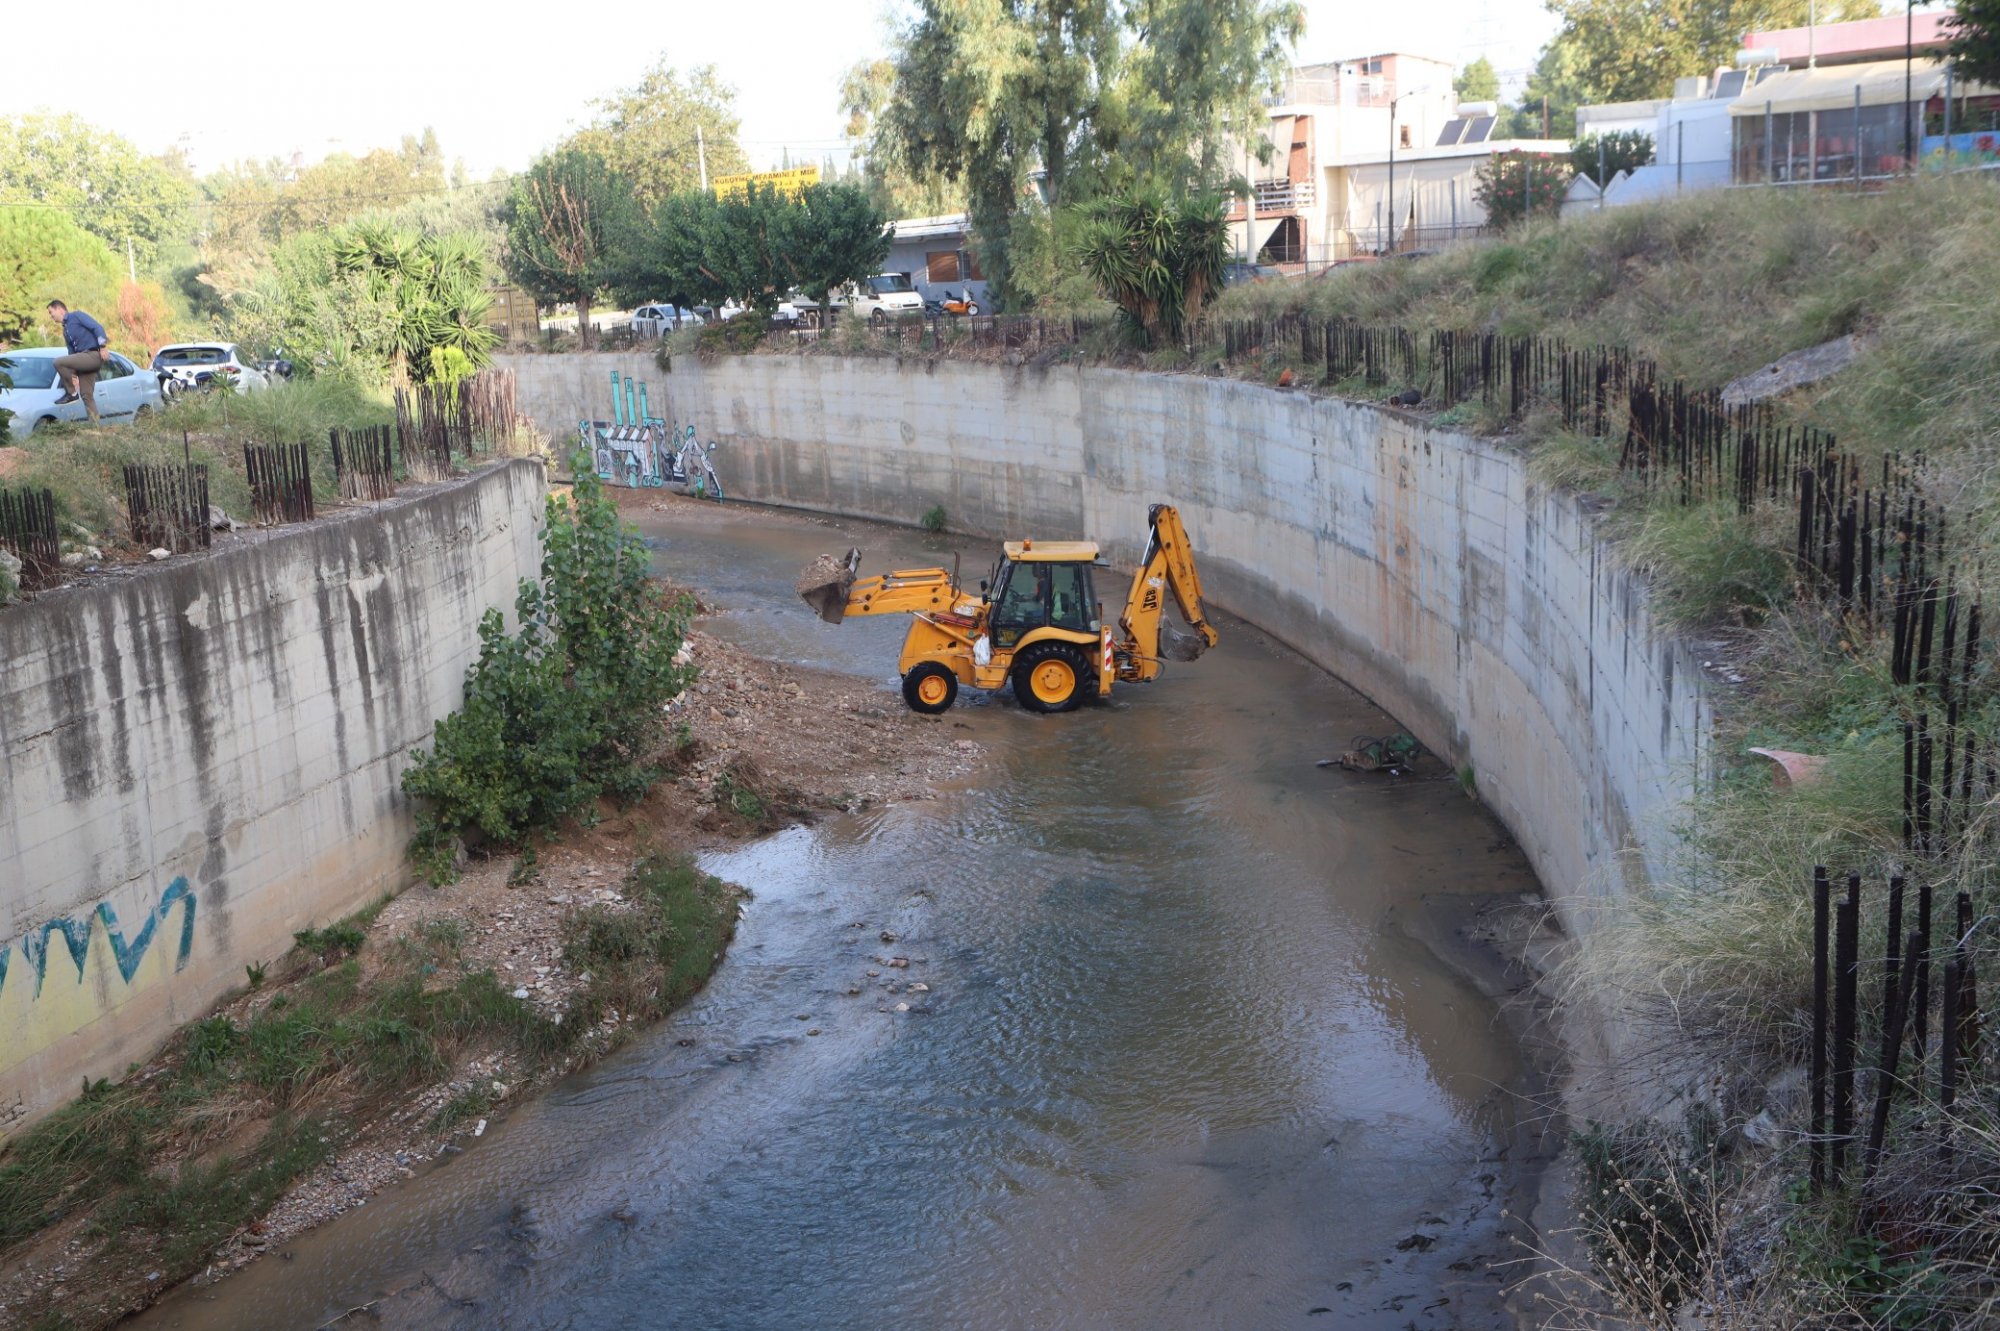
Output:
[138,499,1540,1331]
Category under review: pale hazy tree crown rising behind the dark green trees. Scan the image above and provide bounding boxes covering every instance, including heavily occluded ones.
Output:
[568,56,750,208]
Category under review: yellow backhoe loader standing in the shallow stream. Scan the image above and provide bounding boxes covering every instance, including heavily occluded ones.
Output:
[798,504,1216,713]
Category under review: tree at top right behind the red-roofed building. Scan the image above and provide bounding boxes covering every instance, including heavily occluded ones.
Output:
[1546,0,1882,102]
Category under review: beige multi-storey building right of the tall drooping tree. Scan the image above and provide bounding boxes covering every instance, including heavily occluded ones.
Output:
[1230,52,1570,268]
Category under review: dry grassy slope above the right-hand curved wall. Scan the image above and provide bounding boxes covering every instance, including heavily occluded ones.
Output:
[1216,180,2000,1325]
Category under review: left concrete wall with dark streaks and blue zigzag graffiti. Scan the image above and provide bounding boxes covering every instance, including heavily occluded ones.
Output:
[0,462,542,1131]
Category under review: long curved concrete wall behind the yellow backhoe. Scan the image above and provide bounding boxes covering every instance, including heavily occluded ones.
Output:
[508,354,1710,929]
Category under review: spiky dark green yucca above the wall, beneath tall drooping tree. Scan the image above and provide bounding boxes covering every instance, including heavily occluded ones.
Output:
[1074,188,1228,348]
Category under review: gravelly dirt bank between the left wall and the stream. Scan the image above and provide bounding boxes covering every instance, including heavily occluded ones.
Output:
[0,591,978,1331]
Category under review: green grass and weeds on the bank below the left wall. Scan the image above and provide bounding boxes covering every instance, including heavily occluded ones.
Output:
[0,853,738,1329]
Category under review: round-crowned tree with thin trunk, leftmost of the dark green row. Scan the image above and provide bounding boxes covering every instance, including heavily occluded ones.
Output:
[504,146,642,348]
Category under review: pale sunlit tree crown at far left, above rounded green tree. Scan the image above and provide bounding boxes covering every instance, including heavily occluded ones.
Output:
[0,114,196,264]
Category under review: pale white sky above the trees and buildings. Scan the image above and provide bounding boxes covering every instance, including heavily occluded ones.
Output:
[0,0,1554,178]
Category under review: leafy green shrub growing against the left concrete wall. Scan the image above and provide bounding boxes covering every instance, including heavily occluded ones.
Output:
[402,466,694,883]
